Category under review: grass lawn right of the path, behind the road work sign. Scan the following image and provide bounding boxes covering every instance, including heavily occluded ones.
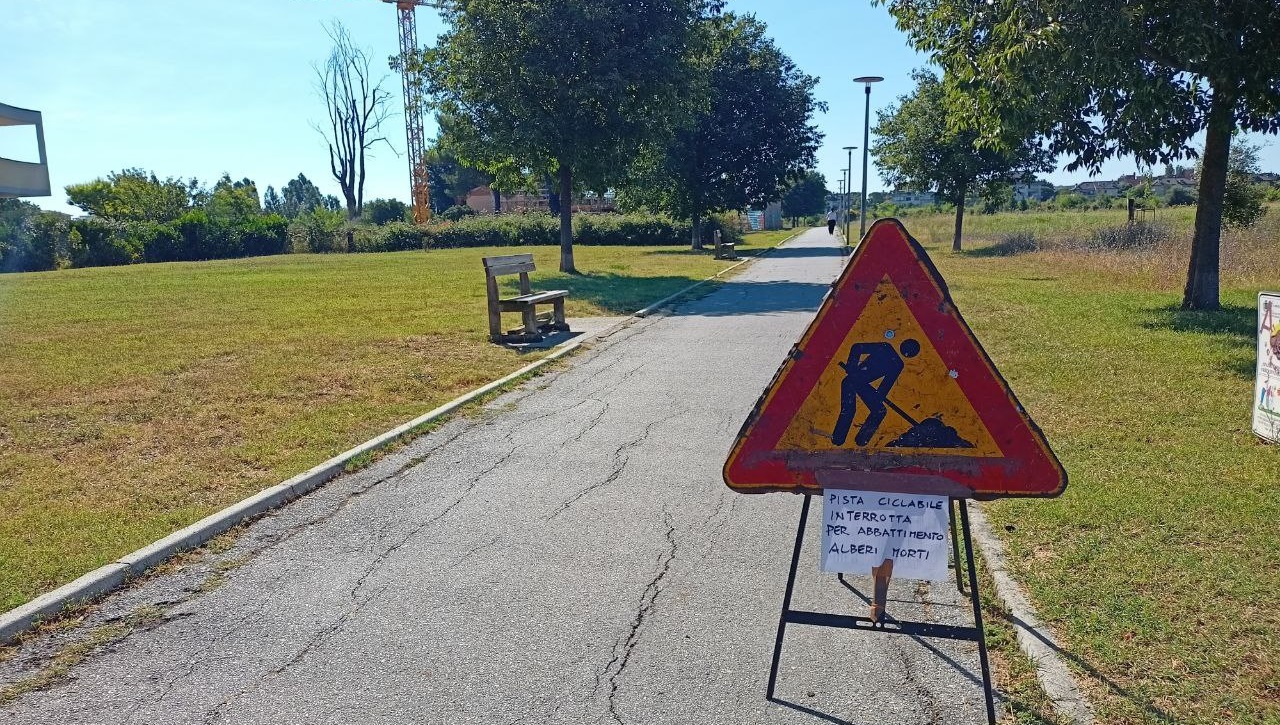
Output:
[905,213,1280,724]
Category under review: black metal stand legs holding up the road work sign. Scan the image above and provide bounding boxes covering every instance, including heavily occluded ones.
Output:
[765,496,996,725]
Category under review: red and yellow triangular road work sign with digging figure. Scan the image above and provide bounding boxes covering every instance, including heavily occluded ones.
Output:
[724,219,1066,498]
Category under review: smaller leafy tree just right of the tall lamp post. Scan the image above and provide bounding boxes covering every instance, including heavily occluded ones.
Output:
[872,70,1050,251]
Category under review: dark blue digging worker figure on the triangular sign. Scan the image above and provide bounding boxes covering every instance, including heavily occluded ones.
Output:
[831,338,920,446]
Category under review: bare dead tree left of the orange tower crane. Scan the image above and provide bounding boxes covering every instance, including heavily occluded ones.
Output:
[314,20,392,219]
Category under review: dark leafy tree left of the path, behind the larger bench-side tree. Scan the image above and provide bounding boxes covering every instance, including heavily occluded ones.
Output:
[628,13,827,248]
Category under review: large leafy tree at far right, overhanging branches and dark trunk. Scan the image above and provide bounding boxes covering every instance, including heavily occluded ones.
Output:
[878,0,1280,309]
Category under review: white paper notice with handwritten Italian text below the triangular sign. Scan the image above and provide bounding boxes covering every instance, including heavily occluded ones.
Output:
[822,489,951,582]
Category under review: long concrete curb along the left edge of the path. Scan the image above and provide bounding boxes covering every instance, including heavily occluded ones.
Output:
[0,232,801,644]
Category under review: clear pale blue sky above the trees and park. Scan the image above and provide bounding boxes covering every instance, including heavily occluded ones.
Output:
[0,0,1280,216]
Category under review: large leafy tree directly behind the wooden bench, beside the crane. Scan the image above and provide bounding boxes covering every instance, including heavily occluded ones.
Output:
[424,0,705,273]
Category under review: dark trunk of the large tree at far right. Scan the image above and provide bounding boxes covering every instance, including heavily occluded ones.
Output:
[1183,85,1235,310]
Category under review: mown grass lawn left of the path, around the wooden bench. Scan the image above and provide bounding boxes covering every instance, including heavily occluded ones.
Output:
[0,232,790,611]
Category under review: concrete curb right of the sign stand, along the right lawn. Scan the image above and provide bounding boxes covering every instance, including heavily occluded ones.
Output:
[969,506,1094,725]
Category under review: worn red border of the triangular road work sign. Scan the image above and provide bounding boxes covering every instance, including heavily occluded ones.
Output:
[724,219,1066,498]
